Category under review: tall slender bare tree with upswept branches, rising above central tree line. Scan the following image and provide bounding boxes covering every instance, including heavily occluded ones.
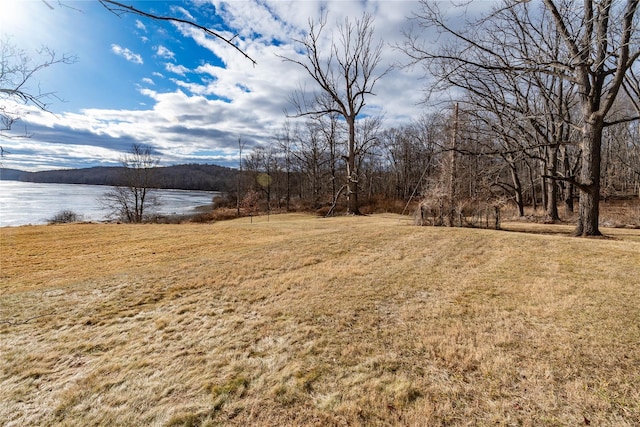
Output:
[283,13,387,214]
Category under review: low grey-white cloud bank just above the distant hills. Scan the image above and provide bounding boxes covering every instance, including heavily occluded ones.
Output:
[3,80,276,170]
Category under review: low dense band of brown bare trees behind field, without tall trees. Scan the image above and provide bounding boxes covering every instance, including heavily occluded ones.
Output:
[239,105,640,221]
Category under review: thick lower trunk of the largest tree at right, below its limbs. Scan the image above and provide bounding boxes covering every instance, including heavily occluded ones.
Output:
[575,119,603,236]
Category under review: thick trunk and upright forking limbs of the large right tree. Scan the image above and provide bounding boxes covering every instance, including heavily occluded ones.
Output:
[544,0,640,236]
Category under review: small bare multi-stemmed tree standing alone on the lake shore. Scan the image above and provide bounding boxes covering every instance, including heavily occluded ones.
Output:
[101,144,160,223]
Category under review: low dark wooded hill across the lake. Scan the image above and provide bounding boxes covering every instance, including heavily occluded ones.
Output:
[0,164,237,191]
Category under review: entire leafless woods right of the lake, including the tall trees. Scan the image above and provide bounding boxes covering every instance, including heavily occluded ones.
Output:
[232,0,640,236]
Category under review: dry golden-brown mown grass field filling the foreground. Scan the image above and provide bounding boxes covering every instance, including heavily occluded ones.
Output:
[0,215,640,426]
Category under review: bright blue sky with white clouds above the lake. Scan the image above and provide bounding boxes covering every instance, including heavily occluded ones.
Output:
[0,0,468,171]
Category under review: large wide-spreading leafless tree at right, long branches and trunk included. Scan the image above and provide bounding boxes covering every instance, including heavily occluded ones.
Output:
[402,0,640,235]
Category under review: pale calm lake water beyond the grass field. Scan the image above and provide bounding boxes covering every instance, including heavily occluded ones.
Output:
[0,181,219,227]
